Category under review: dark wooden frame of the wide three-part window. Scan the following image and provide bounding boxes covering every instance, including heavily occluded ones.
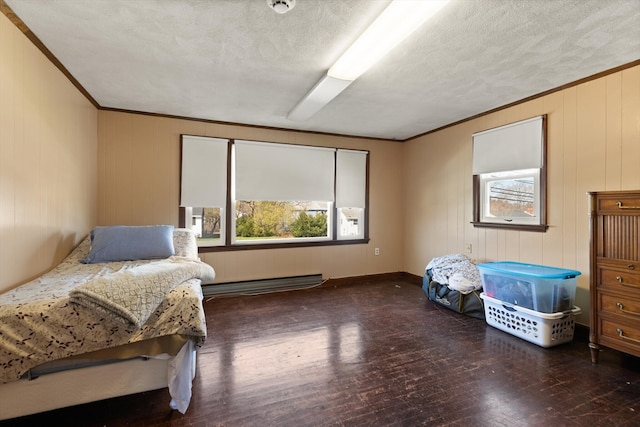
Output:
[178,134,371,253]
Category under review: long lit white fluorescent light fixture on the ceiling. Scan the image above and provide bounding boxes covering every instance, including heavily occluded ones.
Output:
[287,0,449,120]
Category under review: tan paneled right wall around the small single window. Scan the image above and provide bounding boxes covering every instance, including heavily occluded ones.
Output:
[403,67,640,325]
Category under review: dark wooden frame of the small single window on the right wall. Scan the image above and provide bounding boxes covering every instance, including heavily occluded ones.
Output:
[471,114,549,232]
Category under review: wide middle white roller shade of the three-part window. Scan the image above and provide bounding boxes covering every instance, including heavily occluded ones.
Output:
[234,141,335,201]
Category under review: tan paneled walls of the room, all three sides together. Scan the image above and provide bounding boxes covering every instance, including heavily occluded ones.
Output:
[0,2,640,324]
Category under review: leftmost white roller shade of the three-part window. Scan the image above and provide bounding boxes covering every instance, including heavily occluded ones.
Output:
[180,135,228,208]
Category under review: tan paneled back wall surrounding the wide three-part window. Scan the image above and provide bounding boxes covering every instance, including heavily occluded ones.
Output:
[98,111,404,282]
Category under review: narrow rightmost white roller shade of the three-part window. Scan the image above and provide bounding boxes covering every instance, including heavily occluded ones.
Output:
[336,150,368,208]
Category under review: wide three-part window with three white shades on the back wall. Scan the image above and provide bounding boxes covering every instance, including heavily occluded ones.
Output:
[181,136,368,249]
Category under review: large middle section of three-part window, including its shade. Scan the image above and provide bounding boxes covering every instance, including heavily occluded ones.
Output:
[232,141,336,244]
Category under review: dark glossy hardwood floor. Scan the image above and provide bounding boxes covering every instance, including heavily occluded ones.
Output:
[0,280,640,427]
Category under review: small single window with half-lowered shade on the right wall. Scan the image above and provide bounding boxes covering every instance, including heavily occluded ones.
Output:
[473,116,547,231]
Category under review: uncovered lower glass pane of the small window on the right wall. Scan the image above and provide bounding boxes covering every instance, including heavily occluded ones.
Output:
[480,169,540,224]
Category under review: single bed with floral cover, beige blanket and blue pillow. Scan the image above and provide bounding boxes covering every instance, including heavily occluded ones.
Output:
[0,226,215,420]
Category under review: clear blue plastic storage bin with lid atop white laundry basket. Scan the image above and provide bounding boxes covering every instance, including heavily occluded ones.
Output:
[478,261,581,313]
